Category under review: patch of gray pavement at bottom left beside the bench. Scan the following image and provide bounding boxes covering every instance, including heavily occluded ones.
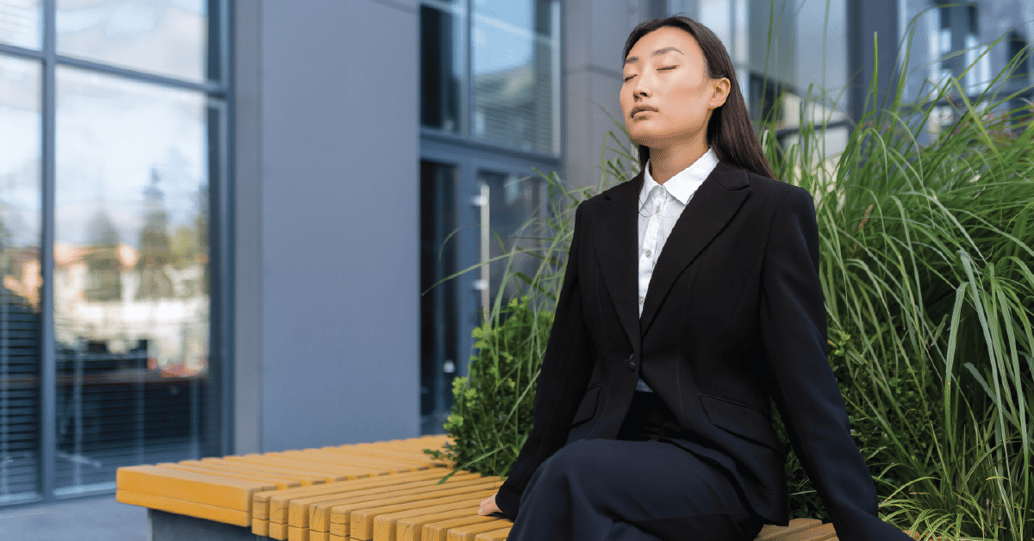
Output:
[0,494,148,541]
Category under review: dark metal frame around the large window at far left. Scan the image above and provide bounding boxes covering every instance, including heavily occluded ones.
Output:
[0,0,235,509]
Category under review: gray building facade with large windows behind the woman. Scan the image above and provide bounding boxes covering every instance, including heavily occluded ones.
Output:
[0,0,1034,506]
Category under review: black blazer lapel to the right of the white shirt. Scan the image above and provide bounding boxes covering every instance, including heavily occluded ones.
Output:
[632,161,751,334]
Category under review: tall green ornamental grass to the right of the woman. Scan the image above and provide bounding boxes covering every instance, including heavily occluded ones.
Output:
[762,14,1034,541]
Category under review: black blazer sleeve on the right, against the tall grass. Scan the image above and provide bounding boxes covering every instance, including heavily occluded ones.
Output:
[759,186,911,541]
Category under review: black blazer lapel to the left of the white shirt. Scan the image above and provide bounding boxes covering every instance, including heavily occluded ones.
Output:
[592,173,642,351]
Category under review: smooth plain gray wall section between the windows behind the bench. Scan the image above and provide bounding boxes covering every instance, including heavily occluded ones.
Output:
[233,0,420,453]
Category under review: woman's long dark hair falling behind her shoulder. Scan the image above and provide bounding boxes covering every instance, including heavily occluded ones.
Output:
[621,16,776,178]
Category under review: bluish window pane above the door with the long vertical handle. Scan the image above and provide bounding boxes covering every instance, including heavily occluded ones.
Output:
[470,0,560,154]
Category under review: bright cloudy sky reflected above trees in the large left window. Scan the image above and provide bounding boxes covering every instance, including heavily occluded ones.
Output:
[56,68,207,244]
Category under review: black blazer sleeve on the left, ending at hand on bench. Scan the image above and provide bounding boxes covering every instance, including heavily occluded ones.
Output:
[495,205,592,520]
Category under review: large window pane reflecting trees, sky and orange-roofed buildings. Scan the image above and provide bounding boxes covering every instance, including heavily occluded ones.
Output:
[54,68,211,494]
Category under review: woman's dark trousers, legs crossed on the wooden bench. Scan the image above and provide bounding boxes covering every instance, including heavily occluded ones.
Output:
[508,392,762,541]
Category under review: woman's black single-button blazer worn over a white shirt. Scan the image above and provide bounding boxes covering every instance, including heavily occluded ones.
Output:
[496,162,909,541]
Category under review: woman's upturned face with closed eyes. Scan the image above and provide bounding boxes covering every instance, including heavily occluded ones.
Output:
[620,27,730,149]
